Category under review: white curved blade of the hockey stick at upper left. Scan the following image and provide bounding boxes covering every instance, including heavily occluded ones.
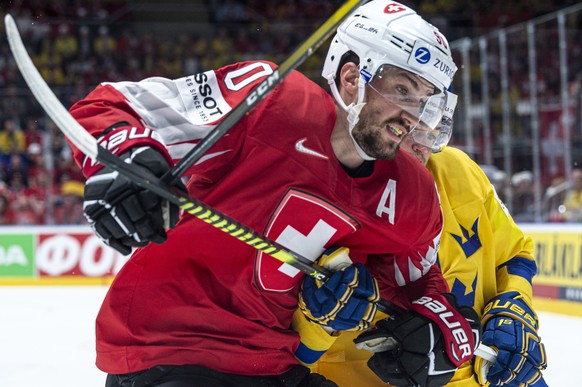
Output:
[4,14,98,159]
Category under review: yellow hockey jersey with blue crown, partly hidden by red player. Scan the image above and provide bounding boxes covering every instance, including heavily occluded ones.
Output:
[310,147,536,387]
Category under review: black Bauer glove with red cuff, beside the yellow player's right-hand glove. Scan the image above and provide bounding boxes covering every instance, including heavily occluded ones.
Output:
[354,294,481,387]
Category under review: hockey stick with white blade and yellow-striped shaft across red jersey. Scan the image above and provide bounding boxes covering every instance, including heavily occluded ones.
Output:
[4,14,495,362]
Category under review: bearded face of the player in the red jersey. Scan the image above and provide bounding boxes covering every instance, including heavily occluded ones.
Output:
[352,66,435,160]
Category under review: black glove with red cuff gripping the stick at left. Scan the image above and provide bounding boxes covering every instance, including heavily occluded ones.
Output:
[83,127,186,255]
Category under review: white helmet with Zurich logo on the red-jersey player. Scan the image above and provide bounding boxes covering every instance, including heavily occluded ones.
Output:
[322,0,457,91]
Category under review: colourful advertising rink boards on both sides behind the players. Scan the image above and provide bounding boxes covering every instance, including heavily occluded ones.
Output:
[0,224,582,316]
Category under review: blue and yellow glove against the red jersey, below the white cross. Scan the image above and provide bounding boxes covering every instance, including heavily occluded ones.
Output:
[299,247,380,331]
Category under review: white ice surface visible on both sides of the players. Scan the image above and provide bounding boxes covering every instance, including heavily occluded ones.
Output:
[0,286,582,387]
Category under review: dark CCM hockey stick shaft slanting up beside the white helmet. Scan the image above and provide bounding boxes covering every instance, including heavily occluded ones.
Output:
[162,0,364,185]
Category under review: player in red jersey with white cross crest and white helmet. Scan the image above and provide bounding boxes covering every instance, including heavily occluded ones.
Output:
[70,0,476,387]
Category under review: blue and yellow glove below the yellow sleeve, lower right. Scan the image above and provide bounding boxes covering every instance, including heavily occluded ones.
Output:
[475,292,547,387]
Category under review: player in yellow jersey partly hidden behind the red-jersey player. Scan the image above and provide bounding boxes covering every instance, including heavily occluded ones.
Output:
[294,110,547,387]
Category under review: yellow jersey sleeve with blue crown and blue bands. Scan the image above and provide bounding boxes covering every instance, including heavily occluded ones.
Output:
[427,147,536,314]
